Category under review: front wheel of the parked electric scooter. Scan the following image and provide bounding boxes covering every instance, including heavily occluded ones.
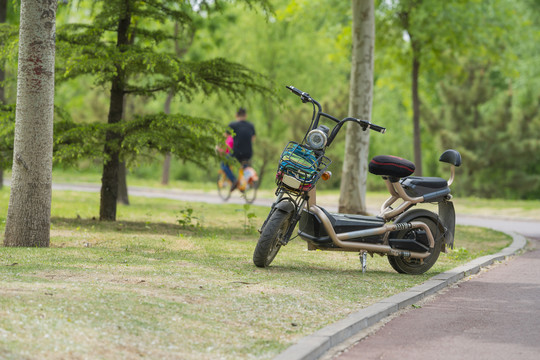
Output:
[253,209,293,267]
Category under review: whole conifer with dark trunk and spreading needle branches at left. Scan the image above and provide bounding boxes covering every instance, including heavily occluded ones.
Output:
[51,0,269,208]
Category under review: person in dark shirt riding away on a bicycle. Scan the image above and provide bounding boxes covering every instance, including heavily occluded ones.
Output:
[224,108,255,189]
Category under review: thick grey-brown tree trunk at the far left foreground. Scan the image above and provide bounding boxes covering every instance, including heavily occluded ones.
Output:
[4,0,56,247]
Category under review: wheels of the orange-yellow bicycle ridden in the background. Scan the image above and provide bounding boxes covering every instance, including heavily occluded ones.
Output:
[217,164,259,204]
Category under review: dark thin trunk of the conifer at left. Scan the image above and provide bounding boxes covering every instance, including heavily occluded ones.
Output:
[99,7,131,221]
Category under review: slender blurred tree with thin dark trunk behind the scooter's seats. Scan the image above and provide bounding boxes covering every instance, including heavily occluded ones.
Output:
[377,0,517,176]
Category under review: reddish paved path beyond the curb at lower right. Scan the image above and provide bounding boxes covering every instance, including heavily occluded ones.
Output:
[330,235,540,360]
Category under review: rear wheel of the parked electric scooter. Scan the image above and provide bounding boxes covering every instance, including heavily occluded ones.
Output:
[388,217,442,275]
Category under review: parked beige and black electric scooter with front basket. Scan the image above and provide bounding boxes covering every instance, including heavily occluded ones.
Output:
[253,86,461,274]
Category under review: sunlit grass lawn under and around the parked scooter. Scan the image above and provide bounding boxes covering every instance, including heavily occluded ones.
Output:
[0,187,511,359]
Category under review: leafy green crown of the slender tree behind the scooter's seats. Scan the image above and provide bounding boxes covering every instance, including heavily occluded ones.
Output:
[375,0,520,174]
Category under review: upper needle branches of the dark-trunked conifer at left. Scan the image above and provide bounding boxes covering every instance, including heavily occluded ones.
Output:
[57,0,265,100]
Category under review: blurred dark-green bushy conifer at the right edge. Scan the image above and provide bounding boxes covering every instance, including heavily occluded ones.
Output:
[433,64,540,198]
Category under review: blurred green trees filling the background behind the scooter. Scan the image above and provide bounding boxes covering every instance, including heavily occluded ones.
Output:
[0,0,540,198]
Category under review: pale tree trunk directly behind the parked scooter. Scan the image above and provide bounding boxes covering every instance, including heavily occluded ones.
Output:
[339,0,375,214]
